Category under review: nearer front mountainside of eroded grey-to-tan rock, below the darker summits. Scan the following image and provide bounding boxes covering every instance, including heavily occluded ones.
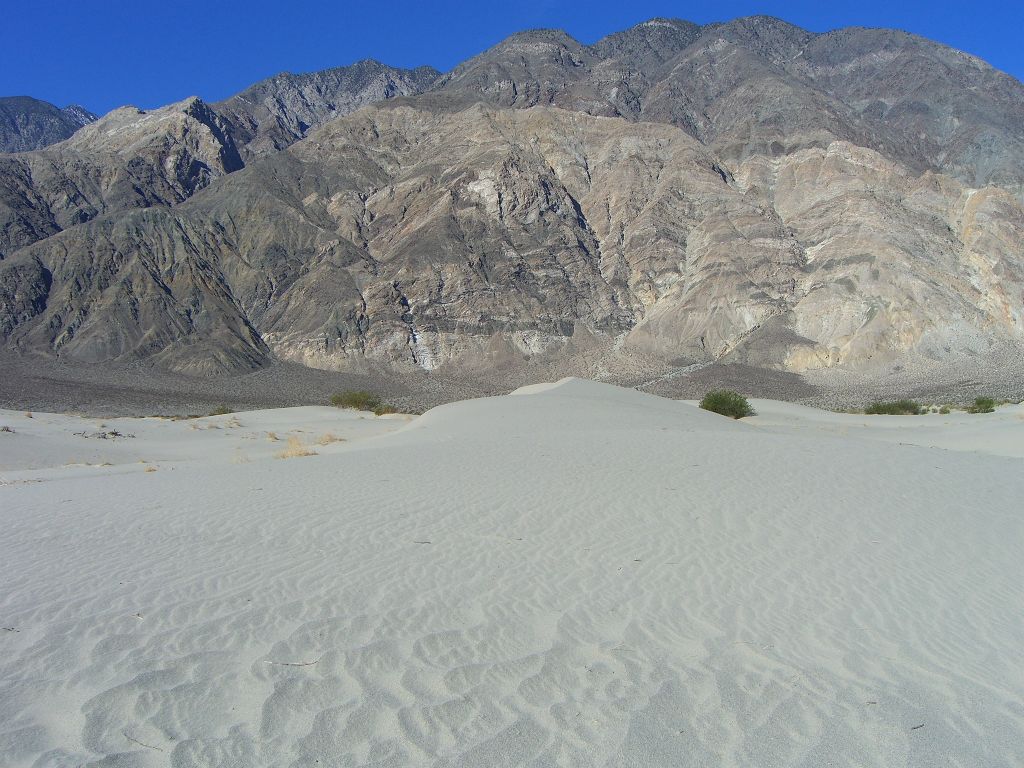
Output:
[0,105,1024,374]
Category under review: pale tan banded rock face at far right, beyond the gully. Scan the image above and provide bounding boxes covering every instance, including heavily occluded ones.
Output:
[737,142,1024,371]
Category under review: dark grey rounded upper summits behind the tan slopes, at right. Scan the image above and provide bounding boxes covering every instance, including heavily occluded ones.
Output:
[441,16,1024,194]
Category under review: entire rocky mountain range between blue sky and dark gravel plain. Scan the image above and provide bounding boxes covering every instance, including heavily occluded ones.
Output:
[0,17,1024,377]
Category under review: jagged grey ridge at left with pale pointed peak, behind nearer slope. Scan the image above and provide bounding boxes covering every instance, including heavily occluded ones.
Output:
[0,61,438,258]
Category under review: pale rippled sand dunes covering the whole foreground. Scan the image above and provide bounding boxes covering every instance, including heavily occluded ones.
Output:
[0,380,1024,768]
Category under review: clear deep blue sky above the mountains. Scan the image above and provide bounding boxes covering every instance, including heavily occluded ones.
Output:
[0,0,1024,113]
